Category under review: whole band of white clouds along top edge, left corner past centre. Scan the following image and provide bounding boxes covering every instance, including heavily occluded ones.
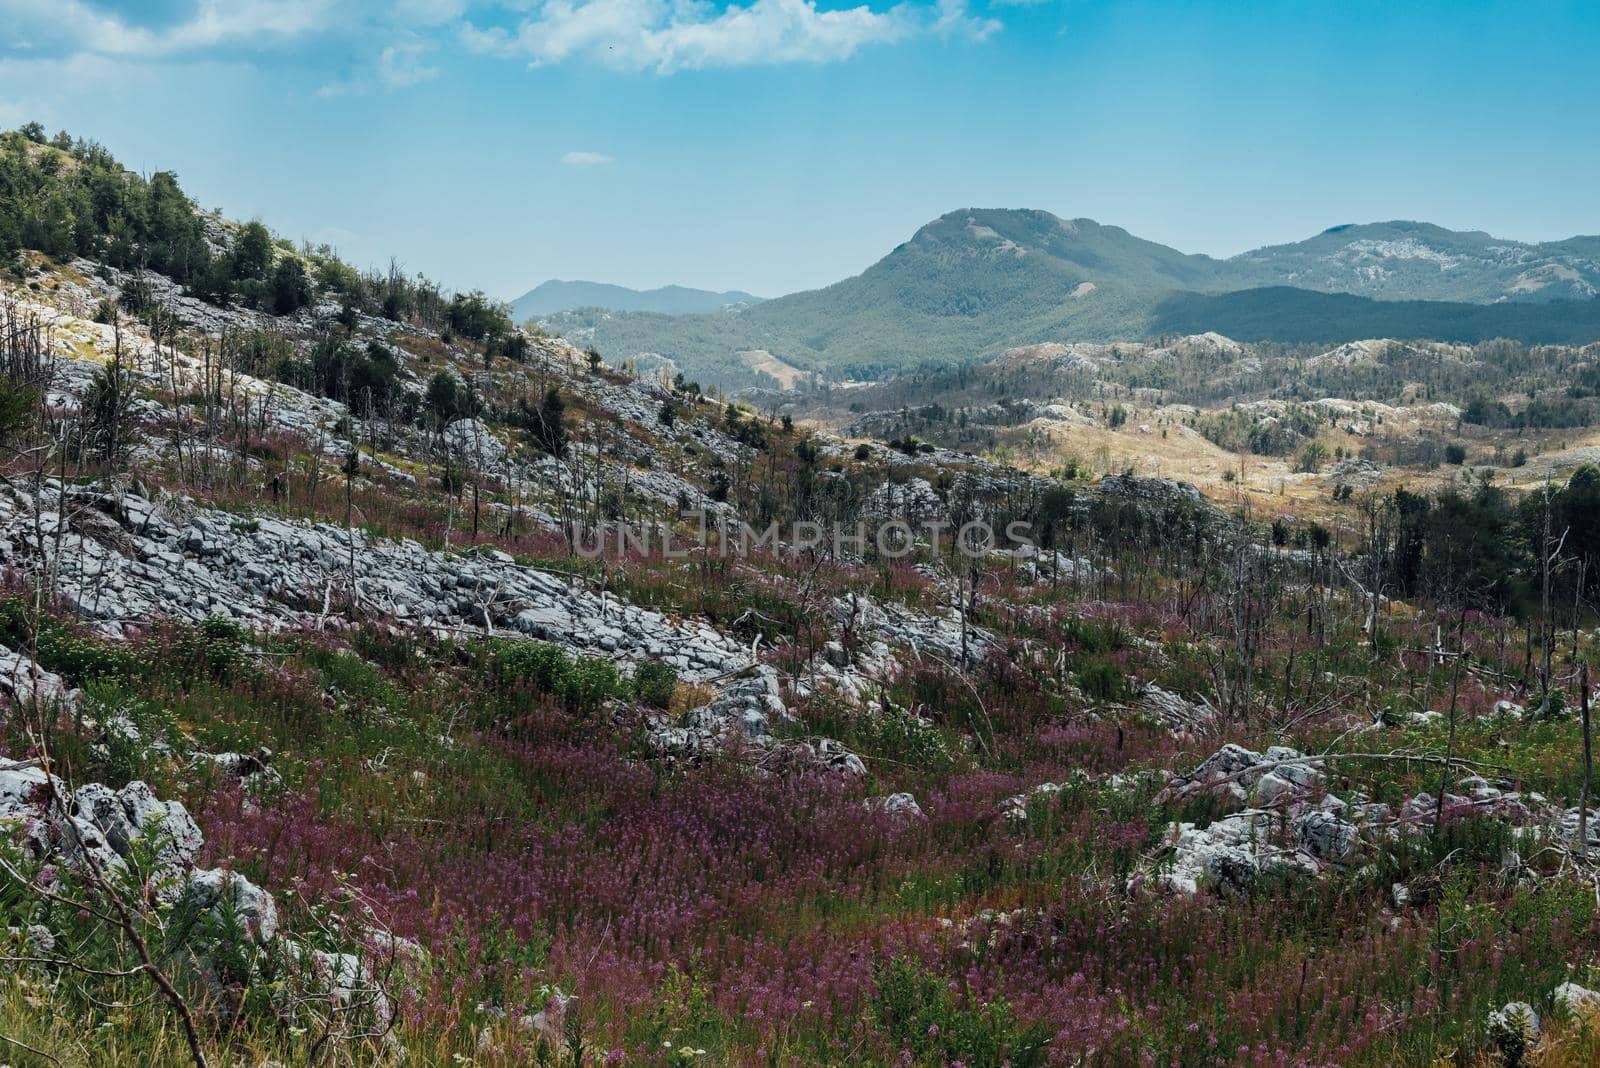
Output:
[0,0,998,87]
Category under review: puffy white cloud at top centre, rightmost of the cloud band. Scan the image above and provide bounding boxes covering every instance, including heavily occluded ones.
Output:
[461,0,998,74]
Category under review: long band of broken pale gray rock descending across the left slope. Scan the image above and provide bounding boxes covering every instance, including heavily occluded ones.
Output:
[0,483,800,758]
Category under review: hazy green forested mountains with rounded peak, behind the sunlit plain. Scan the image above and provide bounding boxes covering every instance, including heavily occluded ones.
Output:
[552,208,1600,385]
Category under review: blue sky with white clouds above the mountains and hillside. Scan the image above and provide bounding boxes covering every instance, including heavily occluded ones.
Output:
[0,0,1600,299]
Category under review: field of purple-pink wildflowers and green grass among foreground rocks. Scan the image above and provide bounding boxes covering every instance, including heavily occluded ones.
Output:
[9,527,1597,1066]
